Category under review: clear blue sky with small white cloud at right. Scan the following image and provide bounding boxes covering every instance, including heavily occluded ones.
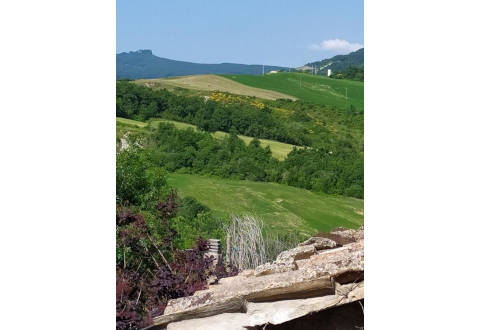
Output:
[117,0,363,67]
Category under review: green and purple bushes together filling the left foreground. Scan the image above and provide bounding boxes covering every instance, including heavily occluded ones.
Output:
[116,146,316,329]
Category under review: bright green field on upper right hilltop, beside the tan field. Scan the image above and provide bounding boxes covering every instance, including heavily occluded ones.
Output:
[223,72,363,110]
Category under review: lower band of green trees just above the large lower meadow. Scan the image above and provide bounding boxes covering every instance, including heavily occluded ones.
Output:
[137,123,363,198]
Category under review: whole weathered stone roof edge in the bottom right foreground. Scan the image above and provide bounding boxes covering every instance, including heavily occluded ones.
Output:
[150,228,364,329]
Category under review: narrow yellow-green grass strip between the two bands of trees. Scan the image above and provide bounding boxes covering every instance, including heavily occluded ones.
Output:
[117,117,294,160]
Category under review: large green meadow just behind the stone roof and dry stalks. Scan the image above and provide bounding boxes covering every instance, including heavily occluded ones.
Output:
[167,174,363,234]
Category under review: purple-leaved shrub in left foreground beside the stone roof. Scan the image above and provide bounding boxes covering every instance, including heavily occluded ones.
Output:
[116,192,236,329]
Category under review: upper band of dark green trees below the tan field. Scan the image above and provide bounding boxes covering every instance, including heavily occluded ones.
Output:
[117,81,309,145]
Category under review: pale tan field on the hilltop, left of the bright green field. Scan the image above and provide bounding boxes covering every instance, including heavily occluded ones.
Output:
[137,74,296,100]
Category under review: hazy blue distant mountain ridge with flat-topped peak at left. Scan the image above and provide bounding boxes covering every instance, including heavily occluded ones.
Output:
[117,49,286,79]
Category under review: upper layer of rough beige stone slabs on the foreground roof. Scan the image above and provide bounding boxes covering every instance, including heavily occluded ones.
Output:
[154,236,364,325]
